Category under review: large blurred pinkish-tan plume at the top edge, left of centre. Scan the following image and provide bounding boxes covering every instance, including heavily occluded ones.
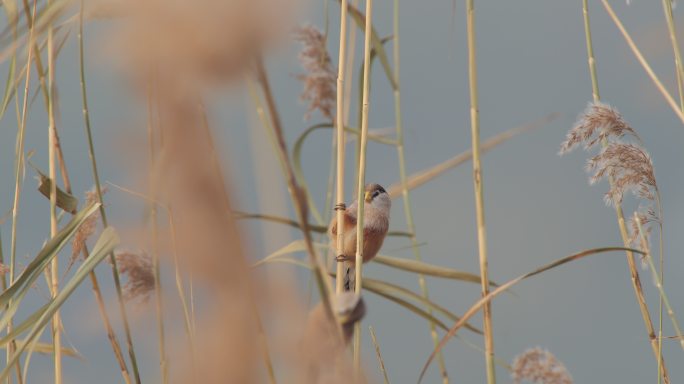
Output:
[108,0,297,86]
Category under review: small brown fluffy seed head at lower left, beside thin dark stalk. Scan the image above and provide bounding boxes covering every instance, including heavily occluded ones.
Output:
[116,251,154,303]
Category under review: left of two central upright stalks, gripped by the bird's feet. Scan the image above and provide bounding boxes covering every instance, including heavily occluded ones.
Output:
[335,0,348,293]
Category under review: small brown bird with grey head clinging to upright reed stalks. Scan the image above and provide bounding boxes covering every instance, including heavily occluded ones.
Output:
[328,183,392,291]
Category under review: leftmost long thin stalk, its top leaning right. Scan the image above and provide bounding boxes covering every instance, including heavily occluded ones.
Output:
[7,1,37,383]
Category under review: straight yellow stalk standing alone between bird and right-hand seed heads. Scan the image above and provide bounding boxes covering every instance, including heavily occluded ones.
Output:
[466,0,496,384]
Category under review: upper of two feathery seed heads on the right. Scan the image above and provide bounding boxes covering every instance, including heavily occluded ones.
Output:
[559,102,639,155]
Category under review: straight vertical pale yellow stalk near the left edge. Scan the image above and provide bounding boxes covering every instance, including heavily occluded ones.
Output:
[47,1,62,384]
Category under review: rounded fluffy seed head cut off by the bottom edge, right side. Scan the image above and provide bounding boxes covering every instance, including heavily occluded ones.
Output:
[511,347,573,384]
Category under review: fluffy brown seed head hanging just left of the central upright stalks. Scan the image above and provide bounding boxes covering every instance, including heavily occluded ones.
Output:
[294,25,337,120]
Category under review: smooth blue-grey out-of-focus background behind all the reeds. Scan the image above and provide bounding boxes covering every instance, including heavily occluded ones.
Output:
[0,0,684,384]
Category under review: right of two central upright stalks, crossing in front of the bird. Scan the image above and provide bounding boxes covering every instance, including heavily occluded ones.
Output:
[354,0,373,372]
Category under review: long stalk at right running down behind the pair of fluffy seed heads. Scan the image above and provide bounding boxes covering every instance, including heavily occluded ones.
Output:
[582,0,681,384]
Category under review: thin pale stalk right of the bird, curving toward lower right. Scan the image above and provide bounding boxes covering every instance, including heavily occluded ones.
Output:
[393,0,449,383]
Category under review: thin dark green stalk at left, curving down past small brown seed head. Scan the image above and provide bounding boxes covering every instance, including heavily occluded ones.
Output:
[78,0,140,384]
